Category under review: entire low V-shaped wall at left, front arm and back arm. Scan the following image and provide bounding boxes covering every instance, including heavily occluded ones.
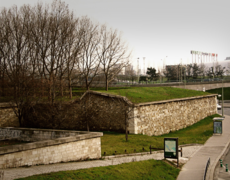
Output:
[0,128,103,168]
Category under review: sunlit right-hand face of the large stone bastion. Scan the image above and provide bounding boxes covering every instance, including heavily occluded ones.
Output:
[129,95,217,136]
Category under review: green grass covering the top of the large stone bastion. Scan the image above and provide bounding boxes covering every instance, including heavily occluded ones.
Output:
[73,87,210,103]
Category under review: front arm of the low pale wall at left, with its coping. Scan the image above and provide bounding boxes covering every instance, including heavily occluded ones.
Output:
[0,129,103,168]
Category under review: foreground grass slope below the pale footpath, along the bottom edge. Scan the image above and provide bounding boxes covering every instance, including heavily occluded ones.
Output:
[18,160,180,180]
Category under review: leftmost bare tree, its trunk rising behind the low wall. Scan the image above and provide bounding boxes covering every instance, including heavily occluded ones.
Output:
[0,5,41,125]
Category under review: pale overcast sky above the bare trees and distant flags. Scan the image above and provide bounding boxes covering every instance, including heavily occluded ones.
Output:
[0,0,230,67]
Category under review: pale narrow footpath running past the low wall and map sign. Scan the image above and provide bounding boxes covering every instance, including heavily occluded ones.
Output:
[0,145,203,180]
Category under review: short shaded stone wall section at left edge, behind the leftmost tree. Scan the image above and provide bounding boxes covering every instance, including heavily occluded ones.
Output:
[0,103,19,127]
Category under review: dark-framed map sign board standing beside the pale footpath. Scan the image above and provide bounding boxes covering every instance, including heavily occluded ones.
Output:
[164,138,178,159]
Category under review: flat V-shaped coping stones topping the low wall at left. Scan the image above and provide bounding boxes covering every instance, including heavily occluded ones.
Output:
[0,127,103,155]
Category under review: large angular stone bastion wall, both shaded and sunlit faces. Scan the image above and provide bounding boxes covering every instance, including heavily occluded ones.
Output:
[1,91,217,135]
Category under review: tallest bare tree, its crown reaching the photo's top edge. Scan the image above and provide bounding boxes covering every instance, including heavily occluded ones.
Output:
[31,0,79,103]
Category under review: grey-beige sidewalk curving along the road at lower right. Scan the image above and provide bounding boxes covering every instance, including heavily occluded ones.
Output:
[177,115,230,180]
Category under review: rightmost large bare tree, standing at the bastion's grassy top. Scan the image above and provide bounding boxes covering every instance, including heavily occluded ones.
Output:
[97,25,131,91]
